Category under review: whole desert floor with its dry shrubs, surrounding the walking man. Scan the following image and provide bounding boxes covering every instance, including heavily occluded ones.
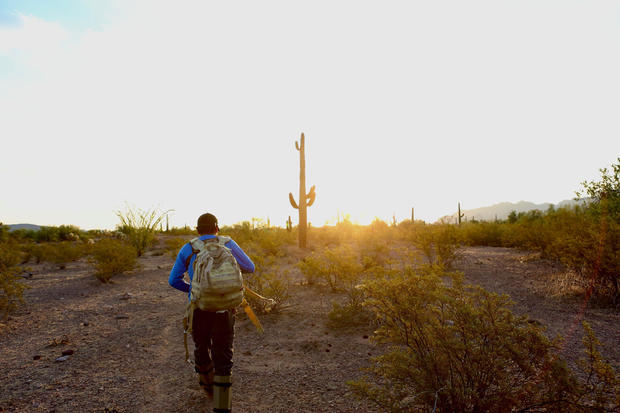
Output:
[0,159,620,412]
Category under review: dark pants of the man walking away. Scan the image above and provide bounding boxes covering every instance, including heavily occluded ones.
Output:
[192,309,235,376]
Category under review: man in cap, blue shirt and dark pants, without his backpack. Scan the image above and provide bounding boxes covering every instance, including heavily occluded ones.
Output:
[168,213,254,413]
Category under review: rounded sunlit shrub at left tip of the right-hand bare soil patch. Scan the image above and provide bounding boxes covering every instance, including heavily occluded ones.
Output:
[412,224,460,268]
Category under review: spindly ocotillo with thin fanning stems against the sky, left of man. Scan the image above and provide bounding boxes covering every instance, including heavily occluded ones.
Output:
[116,206,169,257]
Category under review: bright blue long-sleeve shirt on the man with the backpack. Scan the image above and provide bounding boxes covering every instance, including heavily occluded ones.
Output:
[168,235,255,295]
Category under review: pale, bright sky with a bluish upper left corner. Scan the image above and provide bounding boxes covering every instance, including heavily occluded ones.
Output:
[0,0,620,229]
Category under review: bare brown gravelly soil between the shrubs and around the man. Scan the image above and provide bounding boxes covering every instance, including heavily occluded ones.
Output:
[0,240,620,412]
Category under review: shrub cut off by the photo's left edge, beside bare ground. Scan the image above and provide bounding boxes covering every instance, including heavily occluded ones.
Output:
[0,242,27,318]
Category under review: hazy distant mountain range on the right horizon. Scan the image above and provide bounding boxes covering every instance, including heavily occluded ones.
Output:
[438,199,586,223]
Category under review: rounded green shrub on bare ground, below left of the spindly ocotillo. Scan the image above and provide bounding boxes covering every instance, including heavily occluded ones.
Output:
[89,239,137,283]
